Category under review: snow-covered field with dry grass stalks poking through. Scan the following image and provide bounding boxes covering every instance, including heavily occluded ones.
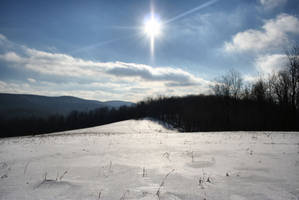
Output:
[0,120,299,200]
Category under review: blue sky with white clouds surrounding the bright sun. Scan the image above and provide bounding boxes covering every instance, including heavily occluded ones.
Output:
[0,0,299,102]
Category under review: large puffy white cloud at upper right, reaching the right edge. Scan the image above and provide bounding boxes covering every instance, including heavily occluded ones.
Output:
[225,14,299,52]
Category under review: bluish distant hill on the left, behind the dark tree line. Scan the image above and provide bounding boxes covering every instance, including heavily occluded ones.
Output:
[0,93,133,119]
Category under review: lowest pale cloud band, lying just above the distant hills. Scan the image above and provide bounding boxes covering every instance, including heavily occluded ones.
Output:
[0,81,208,102]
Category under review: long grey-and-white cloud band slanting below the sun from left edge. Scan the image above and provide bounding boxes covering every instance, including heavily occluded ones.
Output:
[0,48,210,86]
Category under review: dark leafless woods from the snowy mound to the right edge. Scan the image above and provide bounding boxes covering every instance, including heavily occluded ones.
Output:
[137,45,299,131]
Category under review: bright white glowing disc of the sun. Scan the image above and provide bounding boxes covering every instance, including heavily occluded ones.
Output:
[144,15,162,38]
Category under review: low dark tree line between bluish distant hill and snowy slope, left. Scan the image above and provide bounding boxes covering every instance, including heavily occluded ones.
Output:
[0,106,133,137]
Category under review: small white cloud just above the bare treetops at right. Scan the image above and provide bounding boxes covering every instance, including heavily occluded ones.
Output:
[255,54,288,74]
